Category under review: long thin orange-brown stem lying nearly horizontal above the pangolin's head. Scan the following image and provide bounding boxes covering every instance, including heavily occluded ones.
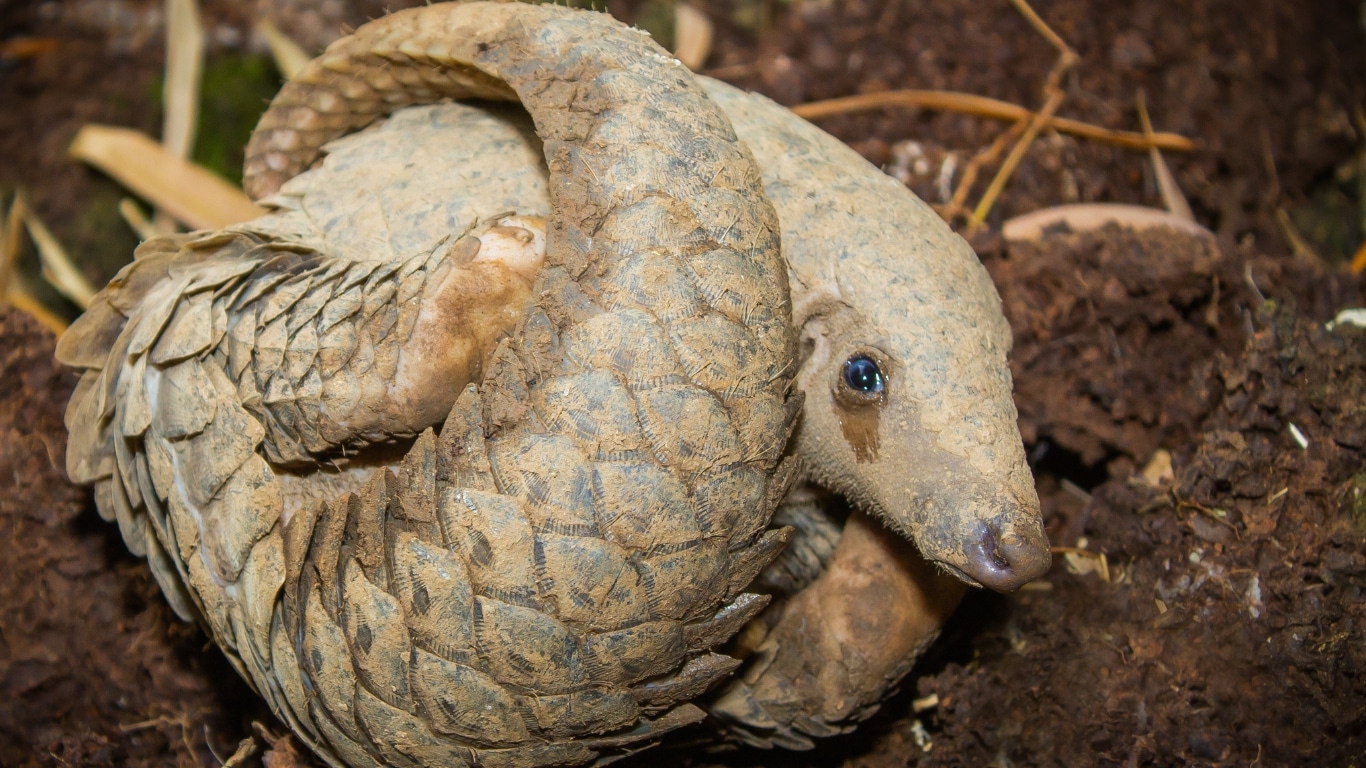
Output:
[792,88,1195,152]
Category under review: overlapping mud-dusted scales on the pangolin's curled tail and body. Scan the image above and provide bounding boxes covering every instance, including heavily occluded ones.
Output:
[60,4,796,765]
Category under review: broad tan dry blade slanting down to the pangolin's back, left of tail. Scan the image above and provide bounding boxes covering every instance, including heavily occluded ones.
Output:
[67,124,265,230]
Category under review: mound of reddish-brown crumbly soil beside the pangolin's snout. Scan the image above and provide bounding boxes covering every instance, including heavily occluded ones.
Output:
[901,231,1366,765]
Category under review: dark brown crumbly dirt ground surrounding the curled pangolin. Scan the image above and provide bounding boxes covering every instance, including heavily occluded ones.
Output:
[0,0,1366,768]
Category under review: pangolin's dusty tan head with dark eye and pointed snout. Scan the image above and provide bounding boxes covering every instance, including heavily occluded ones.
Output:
[794,184,1052,592]
